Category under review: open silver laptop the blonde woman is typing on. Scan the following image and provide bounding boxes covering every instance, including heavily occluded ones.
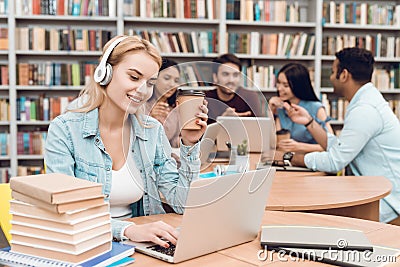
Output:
[128,168,275,263]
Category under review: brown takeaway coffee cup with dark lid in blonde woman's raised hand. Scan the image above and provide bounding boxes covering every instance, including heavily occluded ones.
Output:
[176,88,205,130]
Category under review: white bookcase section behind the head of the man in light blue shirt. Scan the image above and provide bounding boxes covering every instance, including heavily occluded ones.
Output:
[318,0,400,129]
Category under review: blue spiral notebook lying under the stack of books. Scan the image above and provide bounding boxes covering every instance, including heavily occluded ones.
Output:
[0,242,135,267]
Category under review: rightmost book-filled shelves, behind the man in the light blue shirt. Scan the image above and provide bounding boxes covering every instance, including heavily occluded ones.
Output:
[321,0,400,135]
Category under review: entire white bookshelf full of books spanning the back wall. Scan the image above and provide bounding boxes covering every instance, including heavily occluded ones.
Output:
[0,0,400,182]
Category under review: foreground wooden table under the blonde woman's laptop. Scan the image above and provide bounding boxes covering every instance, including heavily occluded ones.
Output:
[126,211,400,267]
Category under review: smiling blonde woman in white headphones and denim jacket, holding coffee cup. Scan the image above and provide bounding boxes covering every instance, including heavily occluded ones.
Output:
[45,36,208,247]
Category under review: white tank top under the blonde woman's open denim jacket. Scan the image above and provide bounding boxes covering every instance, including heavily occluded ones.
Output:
[110,142,144,219]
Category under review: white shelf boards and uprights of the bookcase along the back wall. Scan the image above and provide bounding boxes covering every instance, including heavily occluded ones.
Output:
[0,0,400,181]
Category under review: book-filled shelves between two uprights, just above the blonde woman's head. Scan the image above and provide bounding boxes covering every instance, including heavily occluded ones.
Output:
[123,0,220,60]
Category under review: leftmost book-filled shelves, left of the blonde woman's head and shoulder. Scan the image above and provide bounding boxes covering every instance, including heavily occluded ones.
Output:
[4,0,117,182]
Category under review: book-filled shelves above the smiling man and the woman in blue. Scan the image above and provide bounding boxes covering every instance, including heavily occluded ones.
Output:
[224,0,318,97]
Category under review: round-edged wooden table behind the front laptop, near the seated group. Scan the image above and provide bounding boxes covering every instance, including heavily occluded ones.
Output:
[266,176,392,221]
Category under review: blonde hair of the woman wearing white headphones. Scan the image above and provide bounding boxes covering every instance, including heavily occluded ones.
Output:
[69,35,161,112]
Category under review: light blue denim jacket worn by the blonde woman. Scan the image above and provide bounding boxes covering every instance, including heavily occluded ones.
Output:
[45,109,200,239]
